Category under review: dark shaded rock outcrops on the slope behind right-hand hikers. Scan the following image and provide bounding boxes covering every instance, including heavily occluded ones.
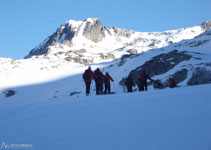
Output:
[119,50,211,85]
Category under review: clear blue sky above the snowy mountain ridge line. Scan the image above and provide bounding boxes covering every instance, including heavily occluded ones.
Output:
[0,0,211,59]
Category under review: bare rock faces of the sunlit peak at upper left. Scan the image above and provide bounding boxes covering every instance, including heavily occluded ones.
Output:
[25,19,105,58]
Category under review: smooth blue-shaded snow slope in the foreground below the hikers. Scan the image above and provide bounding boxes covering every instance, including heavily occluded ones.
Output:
[0,84,211,150]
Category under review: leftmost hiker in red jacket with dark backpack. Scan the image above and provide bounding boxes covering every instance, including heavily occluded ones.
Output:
[83,66,95,96]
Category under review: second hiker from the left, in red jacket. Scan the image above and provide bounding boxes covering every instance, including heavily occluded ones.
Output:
[94,68,105,95]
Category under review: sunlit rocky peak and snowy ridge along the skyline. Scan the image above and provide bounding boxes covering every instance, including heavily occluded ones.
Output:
[26,18,208,63]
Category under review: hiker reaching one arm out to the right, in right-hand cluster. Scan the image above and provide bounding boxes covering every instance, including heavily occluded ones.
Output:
[138,70,153,91]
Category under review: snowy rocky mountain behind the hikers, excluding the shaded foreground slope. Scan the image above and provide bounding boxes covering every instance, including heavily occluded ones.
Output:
[0,18,211,98]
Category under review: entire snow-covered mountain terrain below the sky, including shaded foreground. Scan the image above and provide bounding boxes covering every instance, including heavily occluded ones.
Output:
[0,18,211,150]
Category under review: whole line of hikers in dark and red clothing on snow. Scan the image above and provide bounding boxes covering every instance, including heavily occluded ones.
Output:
[83,66,177,95]
